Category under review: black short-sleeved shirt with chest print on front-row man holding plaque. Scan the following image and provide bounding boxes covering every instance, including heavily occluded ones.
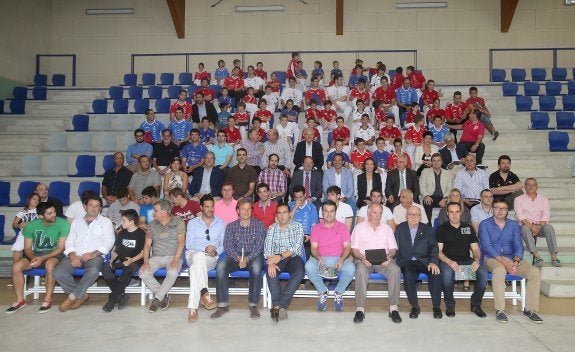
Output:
[437,221,478,263]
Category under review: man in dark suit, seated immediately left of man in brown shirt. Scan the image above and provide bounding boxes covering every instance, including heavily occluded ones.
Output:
[189,152,224,201]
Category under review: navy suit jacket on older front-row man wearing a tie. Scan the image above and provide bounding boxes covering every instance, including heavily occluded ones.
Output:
[395,221,439,267]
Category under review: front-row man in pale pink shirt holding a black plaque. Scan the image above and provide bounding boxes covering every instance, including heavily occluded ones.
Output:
[351,203,401,323]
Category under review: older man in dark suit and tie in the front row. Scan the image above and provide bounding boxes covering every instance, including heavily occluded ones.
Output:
[395,206,443,319]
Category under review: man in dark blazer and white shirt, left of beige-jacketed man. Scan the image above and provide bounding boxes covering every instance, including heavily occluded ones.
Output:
[385,155,419,211]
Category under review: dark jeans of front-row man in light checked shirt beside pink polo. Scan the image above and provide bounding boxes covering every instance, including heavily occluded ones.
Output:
[266,256,305,309]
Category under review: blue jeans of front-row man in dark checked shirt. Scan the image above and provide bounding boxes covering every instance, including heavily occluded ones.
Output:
[216,255,264,307]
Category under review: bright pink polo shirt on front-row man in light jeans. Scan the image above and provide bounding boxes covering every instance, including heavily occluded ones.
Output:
[310,220,351,257]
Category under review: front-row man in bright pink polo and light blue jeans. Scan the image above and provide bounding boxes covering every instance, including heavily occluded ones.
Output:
[305,200,355,311]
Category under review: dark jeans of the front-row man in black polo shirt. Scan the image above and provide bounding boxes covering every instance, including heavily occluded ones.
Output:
[439,259,488,307]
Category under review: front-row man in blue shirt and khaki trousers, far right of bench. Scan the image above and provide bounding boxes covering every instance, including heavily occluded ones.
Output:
[479,199,543,324]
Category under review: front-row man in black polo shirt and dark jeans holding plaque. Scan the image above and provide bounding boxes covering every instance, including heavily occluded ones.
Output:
[437,202,488,318]
